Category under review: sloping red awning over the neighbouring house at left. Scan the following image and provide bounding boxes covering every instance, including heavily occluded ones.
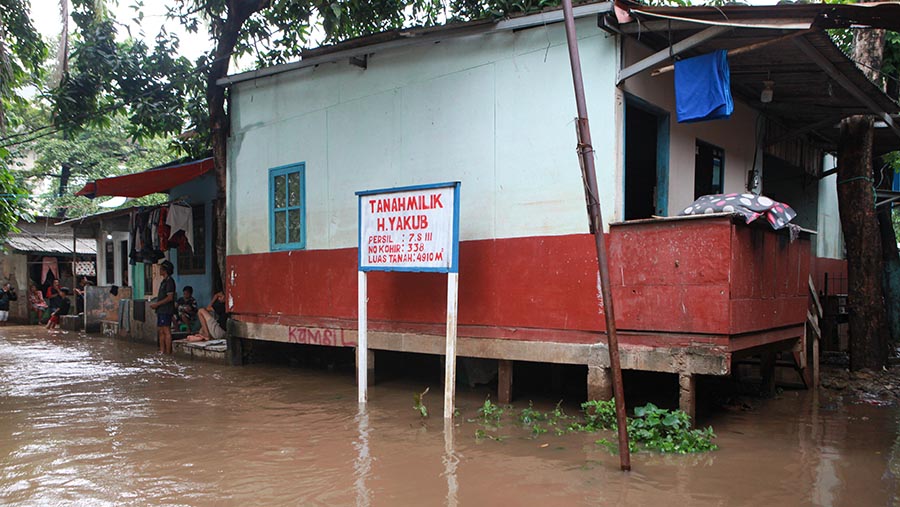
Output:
[75,157,213,199]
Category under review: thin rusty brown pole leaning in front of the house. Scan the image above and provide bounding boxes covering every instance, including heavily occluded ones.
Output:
[563,0,631,470]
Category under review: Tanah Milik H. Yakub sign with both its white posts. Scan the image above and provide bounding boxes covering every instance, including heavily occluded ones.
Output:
[356,181,460,418]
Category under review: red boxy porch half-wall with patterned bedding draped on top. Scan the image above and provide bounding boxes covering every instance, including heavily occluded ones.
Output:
[610,217,810,334]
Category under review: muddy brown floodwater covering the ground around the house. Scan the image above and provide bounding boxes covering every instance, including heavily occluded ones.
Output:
[0,328,900,506]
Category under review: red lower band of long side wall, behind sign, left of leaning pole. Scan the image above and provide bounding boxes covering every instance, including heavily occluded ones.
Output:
[228,234,603,338]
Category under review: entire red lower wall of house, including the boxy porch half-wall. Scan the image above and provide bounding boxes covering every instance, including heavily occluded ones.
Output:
[228,217,810,342]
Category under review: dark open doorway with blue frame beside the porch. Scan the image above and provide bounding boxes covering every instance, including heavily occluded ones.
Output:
[624,95,669,220]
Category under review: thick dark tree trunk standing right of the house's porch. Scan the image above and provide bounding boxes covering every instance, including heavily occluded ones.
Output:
[837,116,888,370]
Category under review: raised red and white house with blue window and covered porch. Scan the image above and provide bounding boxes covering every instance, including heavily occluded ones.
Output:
[227,3,898,411]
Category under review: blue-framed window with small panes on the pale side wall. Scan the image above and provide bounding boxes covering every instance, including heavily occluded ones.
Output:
[269,162,306,250]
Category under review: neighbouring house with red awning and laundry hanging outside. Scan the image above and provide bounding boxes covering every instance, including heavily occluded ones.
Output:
[65,158,217,340]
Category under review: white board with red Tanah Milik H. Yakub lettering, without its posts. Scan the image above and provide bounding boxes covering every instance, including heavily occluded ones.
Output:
[356,182,459,273]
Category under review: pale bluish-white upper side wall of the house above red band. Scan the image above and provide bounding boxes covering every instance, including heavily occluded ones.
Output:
[227,16,620,255]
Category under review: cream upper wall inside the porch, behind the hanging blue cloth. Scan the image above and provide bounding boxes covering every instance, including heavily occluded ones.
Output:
[622,39,762,215]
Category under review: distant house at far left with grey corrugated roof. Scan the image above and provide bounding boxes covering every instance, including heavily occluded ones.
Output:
[0,217,97,322]
